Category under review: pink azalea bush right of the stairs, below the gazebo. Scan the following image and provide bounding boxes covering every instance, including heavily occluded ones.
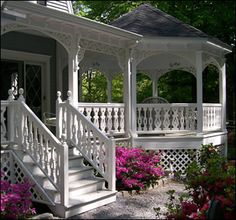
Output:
[116,147,164,191]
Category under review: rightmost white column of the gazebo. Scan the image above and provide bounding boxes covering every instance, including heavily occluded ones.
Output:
[219,62,226,131]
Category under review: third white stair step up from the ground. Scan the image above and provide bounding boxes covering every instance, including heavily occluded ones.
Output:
[69,166,93,182]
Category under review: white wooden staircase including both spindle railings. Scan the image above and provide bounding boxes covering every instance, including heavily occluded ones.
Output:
[1,88,116,218]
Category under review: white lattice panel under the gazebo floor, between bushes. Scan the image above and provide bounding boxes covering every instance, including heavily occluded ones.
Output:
[160,149,198,173]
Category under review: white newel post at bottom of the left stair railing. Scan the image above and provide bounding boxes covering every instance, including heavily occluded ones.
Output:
[60,134,69,206]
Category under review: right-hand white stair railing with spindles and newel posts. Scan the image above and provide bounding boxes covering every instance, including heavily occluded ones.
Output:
[57,92,115,190]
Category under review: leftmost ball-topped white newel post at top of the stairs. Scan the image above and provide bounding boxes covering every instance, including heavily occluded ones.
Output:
[7,89,15,142]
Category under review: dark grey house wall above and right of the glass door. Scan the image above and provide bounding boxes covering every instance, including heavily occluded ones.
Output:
[1,32,56,112]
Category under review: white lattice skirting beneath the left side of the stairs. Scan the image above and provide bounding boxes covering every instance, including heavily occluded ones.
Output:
[1,150,45,203]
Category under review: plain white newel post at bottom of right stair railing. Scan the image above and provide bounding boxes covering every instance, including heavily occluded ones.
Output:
[108,137,116,191]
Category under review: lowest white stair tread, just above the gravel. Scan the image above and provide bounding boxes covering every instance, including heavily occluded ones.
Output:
[68,189,116,207]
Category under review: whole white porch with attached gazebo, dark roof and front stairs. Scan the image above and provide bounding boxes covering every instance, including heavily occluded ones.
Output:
[1,1,231,217]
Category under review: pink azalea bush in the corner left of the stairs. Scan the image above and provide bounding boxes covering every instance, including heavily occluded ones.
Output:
[0,173,36,219]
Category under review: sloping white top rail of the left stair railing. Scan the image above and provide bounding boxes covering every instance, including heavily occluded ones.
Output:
[21,102,61,145]
